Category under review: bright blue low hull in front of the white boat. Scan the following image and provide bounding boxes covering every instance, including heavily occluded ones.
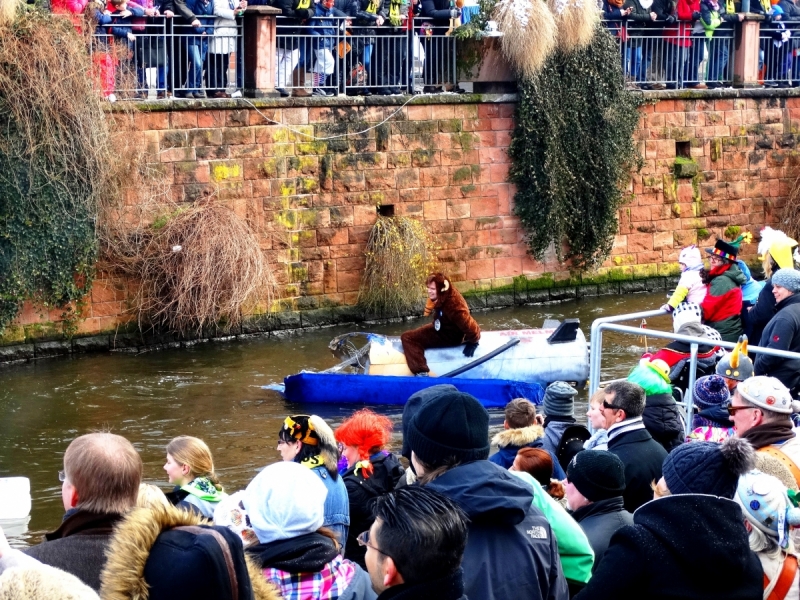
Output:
[272,373,544,408]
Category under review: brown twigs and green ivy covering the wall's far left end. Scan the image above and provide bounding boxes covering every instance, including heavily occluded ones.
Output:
[0,9,108,332]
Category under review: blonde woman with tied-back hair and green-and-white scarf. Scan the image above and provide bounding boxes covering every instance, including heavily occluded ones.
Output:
[164,435,227,519]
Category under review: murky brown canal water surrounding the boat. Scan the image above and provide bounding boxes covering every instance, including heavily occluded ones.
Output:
[0,293,670,547]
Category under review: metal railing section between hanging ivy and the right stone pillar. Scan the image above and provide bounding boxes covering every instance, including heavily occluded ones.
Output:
[604,20,734,89]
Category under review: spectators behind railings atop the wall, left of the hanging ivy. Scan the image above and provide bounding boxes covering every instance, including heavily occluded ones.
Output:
[51,0,461,102]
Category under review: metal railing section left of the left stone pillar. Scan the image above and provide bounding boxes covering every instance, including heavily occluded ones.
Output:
[90,14,244,100]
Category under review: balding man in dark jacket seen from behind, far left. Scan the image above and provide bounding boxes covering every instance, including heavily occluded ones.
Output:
[25,433,142,591]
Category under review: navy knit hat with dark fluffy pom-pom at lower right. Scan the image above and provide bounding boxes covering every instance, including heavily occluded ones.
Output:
[662,438,755,500]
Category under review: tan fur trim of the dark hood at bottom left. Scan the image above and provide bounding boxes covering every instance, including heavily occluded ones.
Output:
[100,506,281,600]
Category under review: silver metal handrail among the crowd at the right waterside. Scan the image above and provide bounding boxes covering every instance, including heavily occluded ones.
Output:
[589,309,800,435]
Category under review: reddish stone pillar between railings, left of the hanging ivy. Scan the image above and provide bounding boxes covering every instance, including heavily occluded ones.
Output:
[244,6,281,98]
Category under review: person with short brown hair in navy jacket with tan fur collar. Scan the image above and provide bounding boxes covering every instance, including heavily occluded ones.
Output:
[489,398,566,480]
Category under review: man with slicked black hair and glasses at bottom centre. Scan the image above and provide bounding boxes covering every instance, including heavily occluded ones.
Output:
[359,486,467,600]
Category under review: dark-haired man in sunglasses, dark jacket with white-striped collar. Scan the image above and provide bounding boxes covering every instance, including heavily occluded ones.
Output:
[601,381,667,513]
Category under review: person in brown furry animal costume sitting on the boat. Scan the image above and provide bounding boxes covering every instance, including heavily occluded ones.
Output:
[400,273,481,376]
